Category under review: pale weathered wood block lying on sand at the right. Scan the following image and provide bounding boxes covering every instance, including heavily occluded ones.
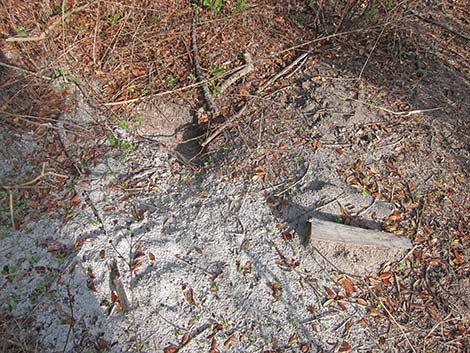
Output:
[308,218,412,249]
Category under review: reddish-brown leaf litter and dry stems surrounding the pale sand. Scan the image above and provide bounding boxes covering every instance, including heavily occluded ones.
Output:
[0,0,470,352]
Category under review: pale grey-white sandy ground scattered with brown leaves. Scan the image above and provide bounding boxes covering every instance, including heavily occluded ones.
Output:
[0,53,466,352]
